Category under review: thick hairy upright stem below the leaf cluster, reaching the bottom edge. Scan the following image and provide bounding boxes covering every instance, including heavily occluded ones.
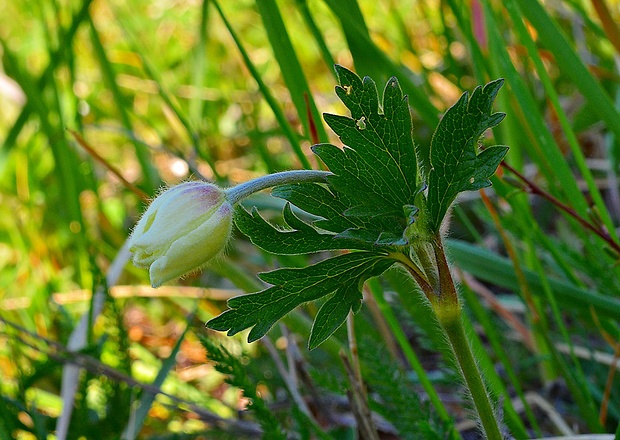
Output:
[434,237,503,440]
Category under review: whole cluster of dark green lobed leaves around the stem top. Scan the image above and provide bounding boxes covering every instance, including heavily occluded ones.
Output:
[207,66,506,348]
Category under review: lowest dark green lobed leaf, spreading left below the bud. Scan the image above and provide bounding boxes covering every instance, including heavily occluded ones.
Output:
[207,252,394,347]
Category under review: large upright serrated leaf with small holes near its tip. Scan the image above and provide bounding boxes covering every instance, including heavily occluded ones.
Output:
[313,66,417,217]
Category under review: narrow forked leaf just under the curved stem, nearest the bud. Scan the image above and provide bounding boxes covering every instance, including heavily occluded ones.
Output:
[235,203,372,255]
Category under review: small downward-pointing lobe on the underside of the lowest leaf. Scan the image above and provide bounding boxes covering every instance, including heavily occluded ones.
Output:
[308,285,362,350]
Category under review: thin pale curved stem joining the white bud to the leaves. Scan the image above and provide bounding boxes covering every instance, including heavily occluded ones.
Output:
[225,170,332,205]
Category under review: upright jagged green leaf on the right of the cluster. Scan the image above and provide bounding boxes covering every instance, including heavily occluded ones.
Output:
[428,79,508,232]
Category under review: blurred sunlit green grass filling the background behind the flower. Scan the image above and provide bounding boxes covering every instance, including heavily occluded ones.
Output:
[0,0,620,438]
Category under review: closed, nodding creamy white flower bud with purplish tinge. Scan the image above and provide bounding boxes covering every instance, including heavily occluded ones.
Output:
[128,182,233,287]
